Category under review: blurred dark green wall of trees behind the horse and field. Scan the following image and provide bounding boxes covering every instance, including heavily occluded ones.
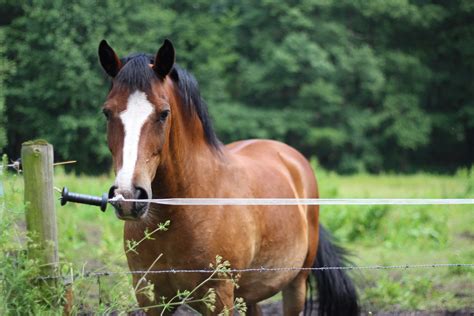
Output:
[0,0,474,174]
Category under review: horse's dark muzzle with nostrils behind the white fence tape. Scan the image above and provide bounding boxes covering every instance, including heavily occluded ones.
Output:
[109,185,149,221]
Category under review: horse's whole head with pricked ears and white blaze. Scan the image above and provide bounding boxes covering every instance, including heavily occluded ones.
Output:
[99,40,175,220]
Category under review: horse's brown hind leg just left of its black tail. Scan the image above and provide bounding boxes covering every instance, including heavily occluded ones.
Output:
[282,271,308,316]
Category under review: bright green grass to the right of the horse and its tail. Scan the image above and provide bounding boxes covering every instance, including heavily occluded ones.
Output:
[317,167,474,311]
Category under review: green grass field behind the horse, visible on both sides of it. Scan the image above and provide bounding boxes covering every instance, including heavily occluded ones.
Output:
[0,165,474,314]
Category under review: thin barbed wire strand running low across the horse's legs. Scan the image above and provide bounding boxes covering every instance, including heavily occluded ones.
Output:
[38,263,474,280]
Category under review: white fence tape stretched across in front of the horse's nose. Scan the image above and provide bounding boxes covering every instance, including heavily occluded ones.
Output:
[109,195,474,205]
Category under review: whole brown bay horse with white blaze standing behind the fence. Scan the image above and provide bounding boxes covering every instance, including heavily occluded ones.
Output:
[99,40,358,315]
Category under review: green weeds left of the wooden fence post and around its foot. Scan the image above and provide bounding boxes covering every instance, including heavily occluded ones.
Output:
[0,168,64,315]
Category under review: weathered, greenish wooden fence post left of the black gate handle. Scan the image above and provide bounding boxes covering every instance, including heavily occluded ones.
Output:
[21,140,59,283]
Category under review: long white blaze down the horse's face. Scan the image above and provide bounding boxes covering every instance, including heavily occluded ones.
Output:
[116,91,153,189]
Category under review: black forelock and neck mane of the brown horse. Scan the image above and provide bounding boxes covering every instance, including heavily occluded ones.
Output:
[115,53,221,149]
